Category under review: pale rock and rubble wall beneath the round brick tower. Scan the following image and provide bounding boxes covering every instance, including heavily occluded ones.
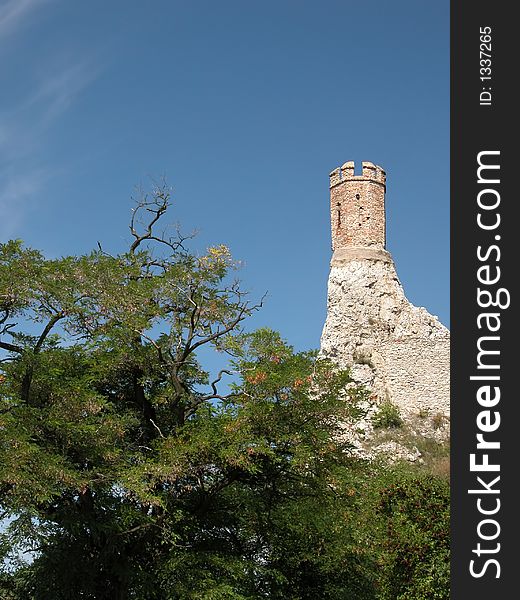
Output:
[321,256,450,420]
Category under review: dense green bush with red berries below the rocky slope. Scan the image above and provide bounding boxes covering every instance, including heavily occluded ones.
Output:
[357,465,450,600]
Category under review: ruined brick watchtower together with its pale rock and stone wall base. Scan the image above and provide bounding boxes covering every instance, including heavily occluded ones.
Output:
[321,161,450,442]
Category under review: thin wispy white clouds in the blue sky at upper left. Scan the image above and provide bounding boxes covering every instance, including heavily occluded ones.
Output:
[0,0,99,238]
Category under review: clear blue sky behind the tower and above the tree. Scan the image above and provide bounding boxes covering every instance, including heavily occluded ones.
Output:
[0,0,449,349]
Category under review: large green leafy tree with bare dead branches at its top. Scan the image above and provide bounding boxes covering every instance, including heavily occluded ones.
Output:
[0,188,375,600]
